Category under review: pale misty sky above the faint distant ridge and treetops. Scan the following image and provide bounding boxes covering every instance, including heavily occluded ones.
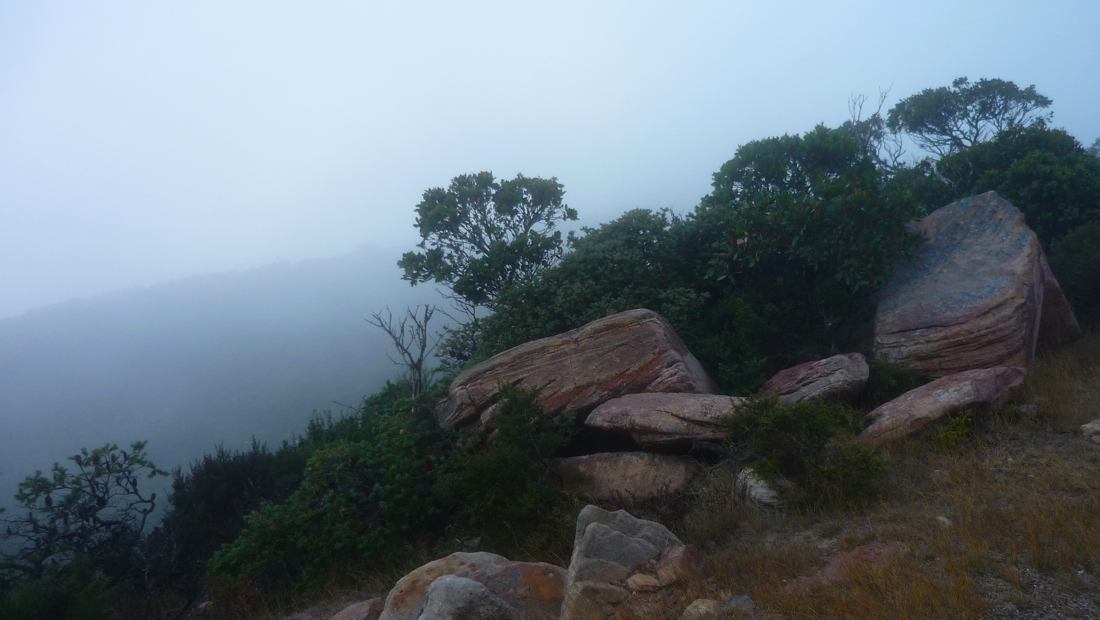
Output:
[0,0,1100,318]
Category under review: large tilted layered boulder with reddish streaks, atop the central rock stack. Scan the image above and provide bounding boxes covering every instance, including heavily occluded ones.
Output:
[438,309,717,427]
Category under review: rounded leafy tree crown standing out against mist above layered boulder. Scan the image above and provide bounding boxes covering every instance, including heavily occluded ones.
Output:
[397,173,576,312]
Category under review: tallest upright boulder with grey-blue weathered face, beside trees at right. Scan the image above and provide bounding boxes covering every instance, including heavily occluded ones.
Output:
[875,191,1053,377]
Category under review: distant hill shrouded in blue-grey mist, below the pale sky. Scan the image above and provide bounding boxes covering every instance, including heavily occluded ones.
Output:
[0,248,442,514]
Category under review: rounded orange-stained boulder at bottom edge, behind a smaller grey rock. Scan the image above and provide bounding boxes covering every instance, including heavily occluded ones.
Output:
[378,552,565,620]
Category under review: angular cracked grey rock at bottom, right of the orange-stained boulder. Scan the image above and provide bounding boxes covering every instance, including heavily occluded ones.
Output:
[561,506,683,620]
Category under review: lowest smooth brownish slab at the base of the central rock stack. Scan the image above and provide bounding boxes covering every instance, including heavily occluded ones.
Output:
[554,452,700,502]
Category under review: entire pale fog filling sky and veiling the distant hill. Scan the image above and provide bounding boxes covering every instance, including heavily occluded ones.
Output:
[0,0,1100,498]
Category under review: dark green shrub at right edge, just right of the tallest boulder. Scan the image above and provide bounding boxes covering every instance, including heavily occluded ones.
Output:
[1051,222,1100,325]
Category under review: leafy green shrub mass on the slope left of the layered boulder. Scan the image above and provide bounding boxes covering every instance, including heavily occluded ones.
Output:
[209,391,446,584]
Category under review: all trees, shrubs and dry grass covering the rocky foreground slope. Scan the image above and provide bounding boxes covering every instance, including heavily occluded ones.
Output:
[0,79,1100,619]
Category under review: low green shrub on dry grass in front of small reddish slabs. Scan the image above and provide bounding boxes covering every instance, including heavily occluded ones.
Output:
[727,398,884,505]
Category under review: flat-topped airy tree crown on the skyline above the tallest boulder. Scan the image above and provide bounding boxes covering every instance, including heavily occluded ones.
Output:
[887,77,1053,156]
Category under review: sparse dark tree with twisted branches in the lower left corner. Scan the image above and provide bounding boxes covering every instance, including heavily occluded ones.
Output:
[0,442,167,583]
